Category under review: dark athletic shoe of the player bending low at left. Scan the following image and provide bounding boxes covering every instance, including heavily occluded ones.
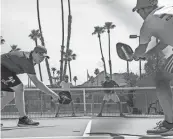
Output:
[17,116,39,127]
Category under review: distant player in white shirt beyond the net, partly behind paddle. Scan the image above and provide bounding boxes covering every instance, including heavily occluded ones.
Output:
[55,75,75,117]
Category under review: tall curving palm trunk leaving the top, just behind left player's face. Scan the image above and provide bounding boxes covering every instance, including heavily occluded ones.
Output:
[37,0,53,85]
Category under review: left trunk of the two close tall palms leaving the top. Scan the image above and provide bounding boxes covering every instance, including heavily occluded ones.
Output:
[60,0,65,82]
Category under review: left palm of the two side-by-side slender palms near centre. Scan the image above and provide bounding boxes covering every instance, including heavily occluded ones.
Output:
[92,26,107,75]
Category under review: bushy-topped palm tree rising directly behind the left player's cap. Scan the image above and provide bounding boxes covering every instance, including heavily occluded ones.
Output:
[29,29,43,81]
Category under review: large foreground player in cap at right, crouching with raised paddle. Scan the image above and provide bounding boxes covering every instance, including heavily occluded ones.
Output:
[133,0,173,135]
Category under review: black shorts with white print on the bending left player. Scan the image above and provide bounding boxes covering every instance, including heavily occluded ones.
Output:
[1,65,22,92]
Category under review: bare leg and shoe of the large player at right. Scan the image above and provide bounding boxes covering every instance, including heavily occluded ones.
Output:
[147,73,173,134]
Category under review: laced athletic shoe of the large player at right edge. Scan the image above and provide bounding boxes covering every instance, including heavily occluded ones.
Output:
[147,120,173,134]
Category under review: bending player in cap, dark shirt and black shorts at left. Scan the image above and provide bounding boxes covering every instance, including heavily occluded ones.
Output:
[1,46,59,126]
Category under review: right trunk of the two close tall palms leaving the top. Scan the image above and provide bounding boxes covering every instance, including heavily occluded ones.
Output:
[63,0,72,77]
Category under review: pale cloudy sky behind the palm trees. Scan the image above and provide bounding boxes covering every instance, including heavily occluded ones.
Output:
[1,0,173,84]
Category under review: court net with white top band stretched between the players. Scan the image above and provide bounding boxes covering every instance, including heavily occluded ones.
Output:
[1,87,163,118]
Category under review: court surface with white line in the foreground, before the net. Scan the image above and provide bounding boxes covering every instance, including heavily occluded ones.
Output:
[1,117,173,139]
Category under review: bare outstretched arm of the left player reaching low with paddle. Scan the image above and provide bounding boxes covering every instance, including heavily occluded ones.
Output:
[28,74,59,100]
